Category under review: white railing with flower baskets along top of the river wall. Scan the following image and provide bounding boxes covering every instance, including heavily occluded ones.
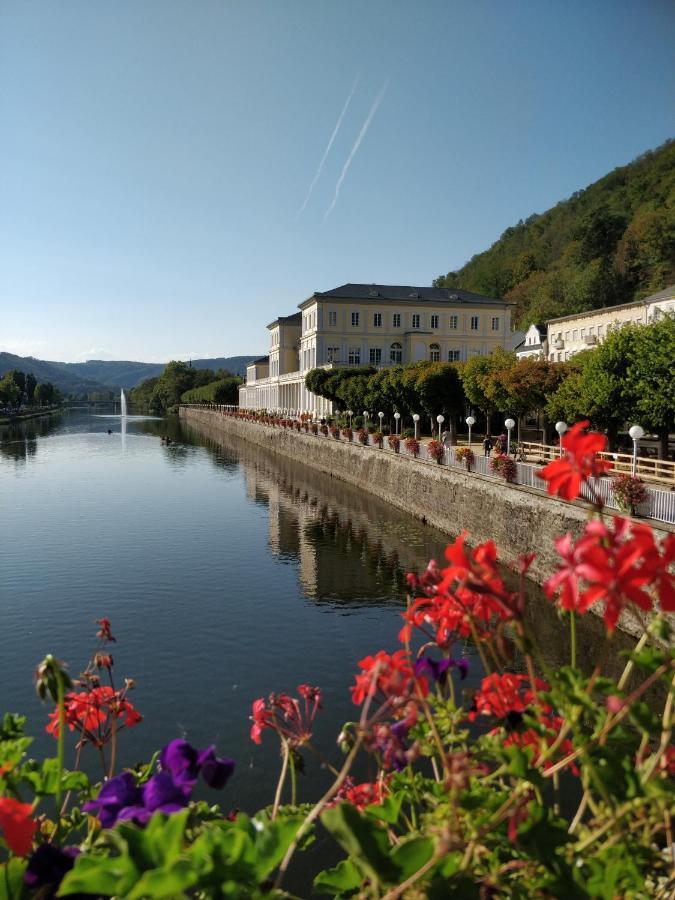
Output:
[184,404,675,524]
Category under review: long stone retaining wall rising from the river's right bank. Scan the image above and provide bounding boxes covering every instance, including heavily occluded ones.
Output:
[180,408,671,582]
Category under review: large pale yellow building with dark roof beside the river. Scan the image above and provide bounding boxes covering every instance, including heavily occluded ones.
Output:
[239,284,511,415]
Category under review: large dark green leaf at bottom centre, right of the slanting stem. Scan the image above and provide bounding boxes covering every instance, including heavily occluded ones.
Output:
[321,803,396,884]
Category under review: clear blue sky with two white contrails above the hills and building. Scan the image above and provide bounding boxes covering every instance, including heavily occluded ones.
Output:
[0,0,675,361]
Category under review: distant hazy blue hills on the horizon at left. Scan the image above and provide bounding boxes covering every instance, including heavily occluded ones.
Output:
[0,353,260,395]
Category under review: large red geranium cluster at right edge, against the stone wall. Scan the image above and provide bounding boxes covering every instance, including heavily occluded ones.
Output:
[544,516,656,632]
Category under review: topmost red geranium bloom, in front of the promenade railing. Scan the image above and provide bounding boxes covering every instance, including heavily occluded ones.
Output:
[537,421,612,500]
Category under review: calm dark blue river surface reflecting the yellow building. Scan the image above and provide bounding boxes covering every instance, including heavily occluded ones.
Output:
[0,411,616,824]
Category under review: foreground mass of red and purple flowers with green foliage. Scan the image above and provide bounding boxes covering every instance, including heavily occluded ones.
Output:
[0,423,675,900]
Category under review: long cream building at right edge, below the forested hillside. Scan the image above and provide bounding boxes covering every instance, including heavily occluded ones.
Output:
[546,285,675,362]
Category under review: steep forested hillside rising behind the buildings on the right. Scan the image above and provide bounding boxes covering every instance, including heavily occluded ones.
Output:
[434,141,675,327]
